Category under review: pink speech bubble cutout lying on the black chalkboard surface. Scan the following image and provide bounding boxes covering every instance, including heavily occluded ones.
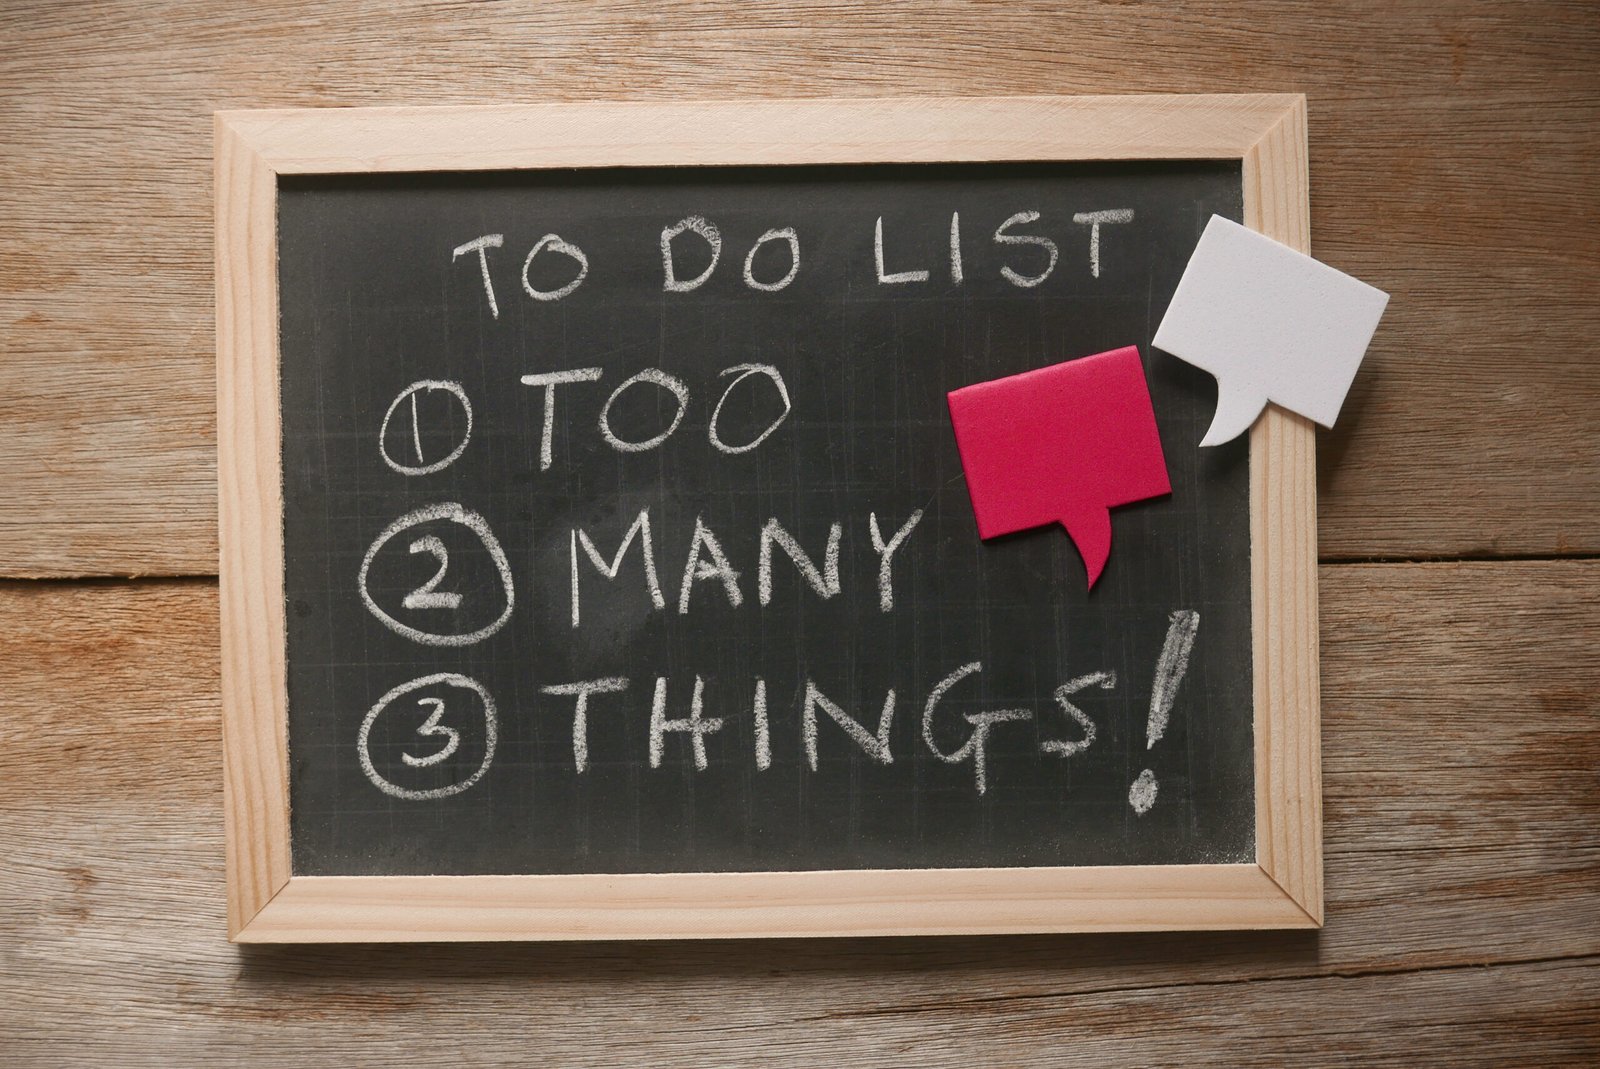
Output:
[949,346,1173,587]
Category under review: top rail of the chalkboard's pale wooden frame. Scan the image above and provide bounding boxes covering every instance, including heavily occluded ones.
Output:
[218,93,1304,172]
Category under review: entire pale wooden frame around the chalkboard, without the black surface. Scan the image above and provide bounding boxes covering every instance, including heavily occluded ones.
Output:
[216,94,1322,943]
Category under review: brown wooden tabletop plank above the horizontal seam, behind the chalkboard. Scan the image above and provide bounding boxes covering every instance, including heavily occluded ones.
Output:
[0,0,1600,575]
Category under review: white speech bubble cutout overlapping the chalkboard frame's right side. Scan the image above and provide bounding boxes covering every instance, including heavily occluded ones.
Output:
[1154,216,1389,445]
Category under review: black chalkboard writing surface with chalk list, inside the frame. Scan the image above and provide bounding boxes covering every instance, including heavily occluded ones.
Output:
[277,158,1256,875]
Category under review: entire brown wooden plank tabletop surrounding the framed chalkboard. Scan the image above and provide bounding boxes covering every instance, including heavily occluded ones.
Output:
[0,0,1600,1066]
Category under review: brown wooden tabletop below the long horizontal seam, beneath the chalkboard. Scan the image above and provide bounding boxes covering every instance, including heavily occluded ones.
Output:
[0,562,1600,1067]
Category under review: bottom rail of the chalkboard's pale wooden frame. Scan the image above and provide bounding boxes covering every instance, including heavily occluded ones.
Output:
[243,864,1315,943]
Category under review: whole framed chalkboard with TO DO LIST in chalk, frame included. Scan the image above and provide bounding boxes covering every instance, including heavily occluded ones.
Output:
[216,94,1322,943]
